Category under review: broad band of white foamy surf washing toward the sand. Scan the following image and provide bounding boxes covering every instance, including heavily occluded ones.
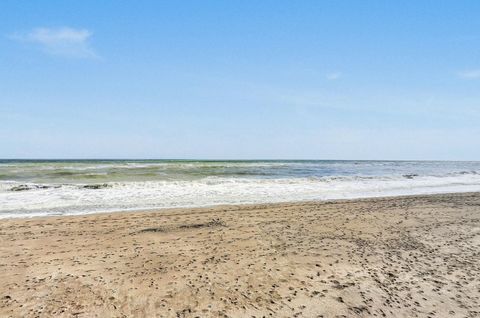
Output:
[0,173,480,218]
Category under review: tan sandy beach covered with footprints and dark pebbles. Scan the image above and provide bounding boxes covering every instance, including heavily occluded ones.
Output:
[0,193,480,317]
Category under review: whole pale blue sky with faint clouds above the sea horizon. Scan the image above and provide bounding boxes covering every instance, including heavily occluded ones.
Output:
[0,0,480,160]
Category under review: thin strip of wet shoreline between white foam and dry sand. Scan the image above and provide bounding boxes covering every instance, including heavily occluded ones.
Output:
[0,191,480,222]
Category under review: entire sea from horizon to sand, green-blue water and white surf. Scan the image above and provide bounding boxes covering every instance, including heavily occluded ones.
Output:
[0,160,480,218]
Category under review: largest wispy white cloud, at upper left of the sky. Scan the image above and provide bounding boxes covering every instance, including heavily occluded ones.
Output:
[10,27,98,58]
